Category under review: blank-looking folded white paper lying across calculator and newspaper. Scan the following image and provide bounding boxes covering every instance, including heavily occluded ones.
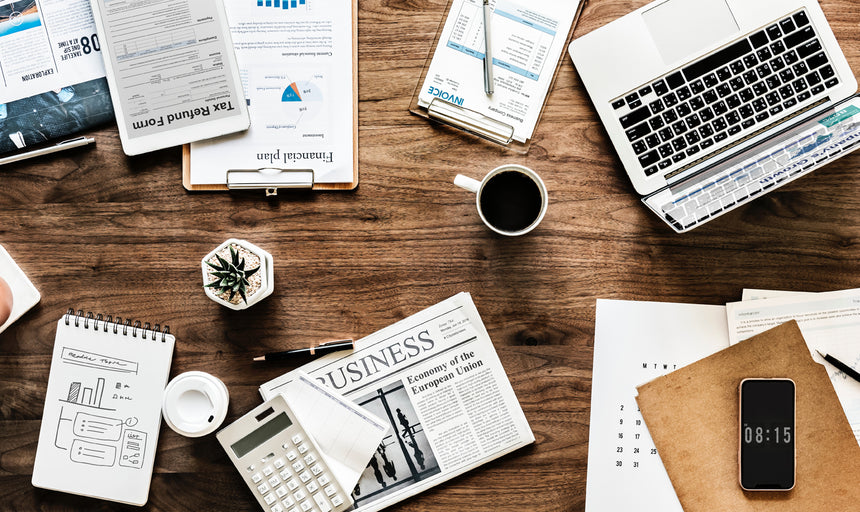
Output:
[282,372,388,491]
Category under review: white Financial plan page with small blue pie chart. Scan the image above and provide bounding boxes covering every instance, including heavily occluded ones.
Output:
[191,0,356,185]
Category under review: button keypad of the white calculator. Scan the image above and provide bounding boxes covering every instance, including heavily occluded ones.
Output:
[250,434,344,512]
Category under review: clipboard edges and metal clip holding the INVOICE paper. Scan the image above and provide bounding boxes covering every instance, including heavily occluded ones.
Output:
[409,0,588,155]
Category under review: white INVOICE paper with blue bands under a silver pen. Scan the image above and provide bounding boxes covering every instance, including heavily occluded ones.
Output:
[418,0,580,142]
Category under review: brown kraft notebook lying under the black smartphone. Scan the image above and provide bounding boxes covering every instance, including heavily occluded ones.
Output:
[637,320,860,512]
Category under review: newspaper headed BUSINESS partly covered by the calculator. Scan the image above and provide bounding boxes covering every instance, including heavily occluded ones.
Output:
[260,293,534,512]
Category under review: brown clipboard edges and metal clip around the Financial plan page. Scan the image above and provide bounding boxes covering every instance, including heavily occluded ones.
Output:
[182,0,358,196]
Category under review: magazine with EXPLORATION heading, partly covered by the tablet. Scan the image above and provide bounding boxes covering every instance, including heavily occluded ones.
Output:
[0,0,114,154]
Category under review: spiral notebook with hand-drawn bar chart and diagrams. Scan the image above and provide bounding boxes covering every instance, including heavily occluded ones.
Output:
[33,310,175,505]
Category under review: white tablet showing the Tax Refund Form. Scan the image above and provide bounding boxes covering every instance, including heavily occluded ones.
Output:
[88,0,250,155]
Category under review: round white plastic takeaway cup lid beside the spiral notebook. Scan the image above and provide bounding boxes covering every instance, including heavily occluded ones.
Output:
[162,371,230,437]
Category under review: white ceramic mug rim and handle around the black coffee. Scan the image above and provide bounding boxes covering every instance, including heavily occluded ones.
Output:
[454,164,549,236]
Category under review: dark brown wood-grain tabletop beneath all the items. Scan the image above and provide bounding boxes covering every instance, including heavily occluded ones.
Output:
[0,0,860,511]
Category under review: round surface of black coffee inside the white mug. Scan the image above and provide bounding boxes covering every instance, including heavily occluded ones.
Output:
[480,171,543,232]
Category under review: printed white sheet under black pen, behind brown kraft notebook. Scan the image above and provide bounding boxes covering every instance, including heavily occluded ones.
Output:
[726,289,860,443]
